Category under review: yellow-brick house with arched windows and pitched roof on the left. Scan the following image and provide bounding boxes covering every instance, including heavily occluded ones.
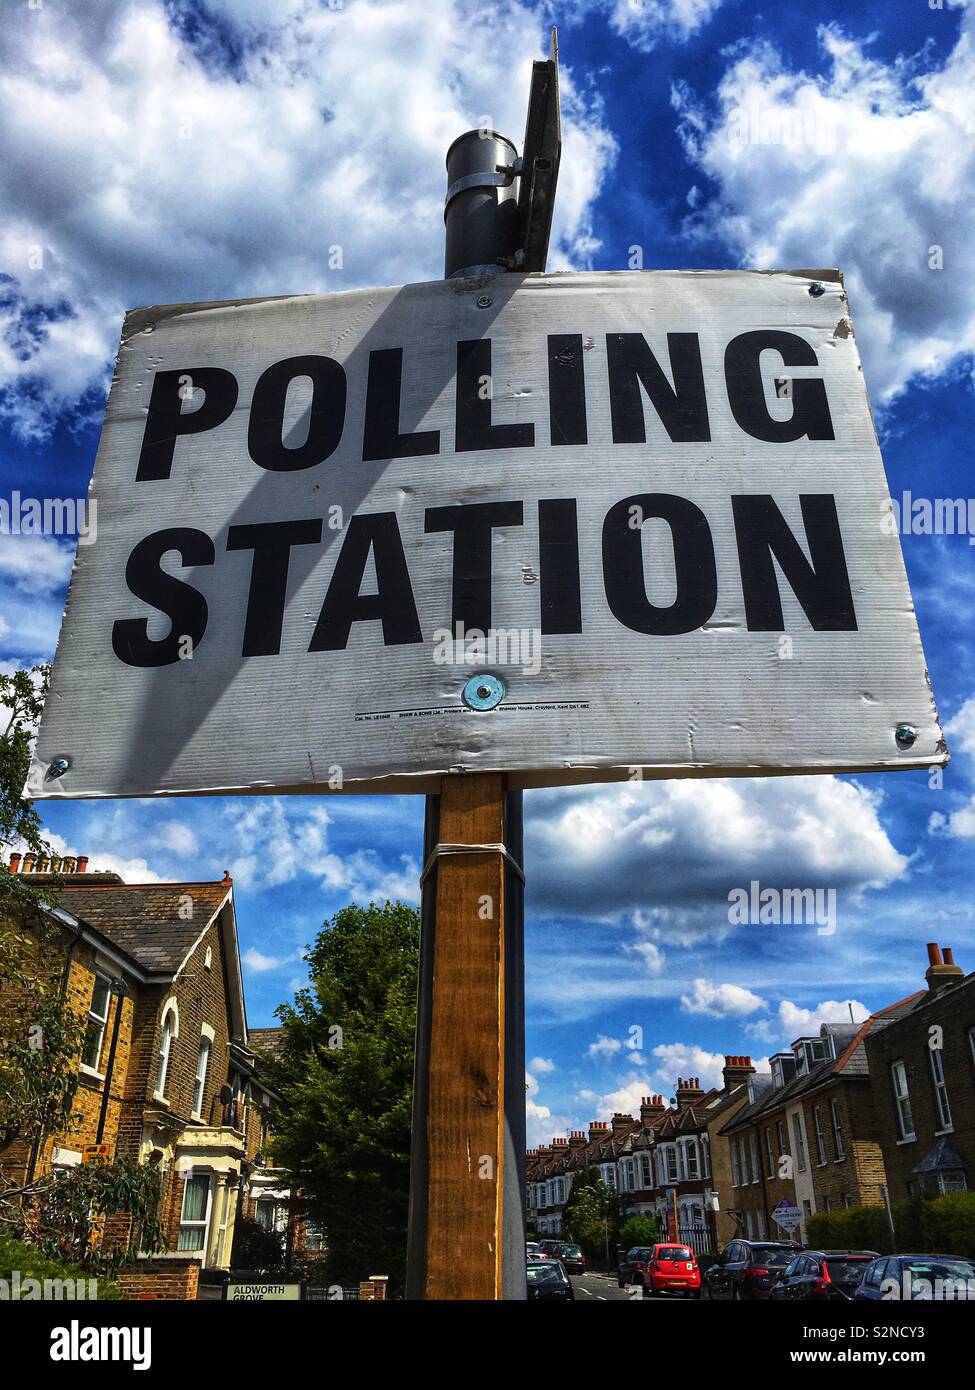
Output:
[3,855,304,1297]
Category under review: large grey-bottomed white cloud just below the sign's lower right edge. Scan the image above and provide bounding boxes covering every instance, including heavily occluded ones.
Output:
[526,777,907,934]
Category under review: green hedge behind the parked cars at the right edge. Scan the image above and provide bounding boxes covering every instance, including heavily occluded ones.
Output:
[805,1193,975,1259]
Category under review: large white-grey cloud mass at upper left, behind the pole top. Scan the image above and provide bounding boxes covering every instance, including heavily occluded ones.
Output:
[0,0,615,438]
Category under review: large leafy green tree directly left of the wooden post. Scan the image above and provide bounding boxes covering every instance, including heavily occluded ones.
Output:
[262,902,420,1284]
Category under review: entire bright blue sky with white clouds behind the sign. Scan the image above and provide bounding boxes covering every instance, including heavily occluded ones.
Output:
[0,0,975,1140]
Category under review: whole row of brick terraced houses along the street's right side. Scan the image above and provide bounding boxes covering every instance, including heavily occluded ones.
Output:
[527,942,975,1252]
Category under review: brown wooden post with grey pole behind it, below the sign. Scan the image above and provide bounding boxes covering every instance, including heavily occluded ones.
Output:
[408,773,524,1300]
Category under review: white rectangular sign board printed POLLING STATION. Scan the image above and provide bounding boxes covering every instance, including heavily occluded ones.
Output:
[31,271,947,796]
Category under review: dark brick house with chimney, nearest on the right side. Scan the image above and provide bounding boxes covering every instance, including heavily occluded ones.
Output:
[867,942,975,1200]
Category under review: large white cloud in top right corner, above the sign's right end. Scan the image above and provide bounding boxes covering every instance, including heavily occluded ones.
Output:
[675,10,975,402]
